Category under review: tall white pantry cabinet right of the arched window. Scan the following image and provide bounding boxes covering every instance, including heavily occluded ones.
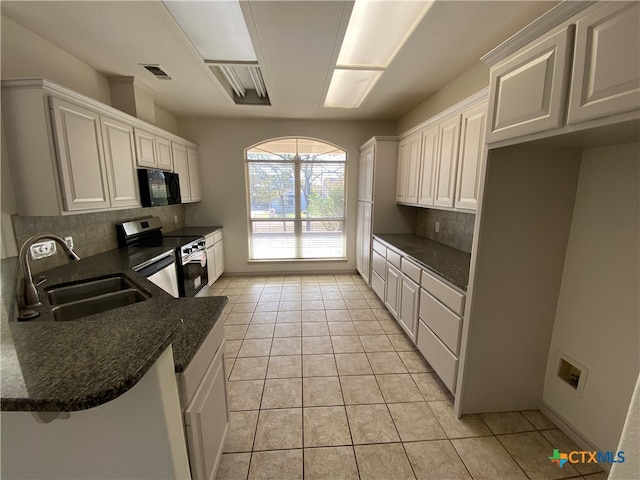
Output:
[356,137,415,283]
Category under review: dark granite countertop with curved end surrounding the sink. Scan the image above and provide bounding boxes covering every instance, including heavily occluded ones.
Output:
[0,247,227,412]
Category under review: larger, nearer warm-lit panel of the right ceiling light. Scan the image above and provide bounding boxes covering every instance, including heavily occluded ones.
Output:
[338,0,433,68]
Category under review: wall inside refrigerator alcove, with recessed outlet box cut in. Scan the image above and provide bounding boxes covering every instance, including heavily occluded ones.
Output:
[543,143,640,453]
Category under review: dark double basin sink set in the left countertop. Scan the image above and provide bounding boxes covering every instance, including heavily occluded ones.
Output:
[45,275,151,321]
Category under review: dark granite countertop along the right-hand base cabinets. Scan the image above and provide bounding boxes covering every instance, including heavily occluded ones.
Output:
[373,233,471,291]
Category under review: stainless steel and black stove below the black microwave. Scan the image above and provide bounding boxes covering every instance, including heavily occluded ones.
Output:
[116,217,209,297]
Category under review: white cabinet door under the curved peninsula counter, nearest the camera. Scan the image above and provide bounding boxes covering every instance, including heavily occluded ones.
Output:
[184,343,229,479]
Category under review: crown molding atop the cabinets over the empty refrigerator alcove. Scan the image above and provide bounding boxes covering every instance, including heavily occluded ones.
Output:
[480,0,597,66]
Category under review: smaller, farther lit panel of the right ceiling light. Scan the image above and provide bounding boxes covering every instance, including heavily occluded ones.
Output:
[324,69,382,108]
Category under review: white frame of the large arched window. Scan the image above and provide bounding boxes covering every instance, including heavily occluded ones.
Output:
[244,136,349,263]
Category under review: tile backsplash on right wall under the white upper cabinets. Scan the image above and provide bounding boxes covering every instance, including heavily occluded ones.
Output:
[416,208,476,253]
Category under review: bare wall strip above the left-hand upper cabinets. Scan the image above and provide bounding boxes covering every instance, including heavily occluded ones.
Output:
[1,16,111,105]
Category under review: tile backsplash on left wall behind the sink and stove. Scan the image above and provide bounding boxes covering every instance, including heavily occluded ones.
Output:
[12,205,185,273]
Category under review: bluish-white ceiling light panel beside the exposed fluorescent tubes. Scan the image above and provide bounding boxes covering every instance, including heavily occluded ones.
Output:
[164,0,257,62]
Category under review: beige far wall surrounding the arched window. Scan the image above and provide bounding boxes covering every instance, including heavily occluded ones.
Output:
[179,119,395,273]
